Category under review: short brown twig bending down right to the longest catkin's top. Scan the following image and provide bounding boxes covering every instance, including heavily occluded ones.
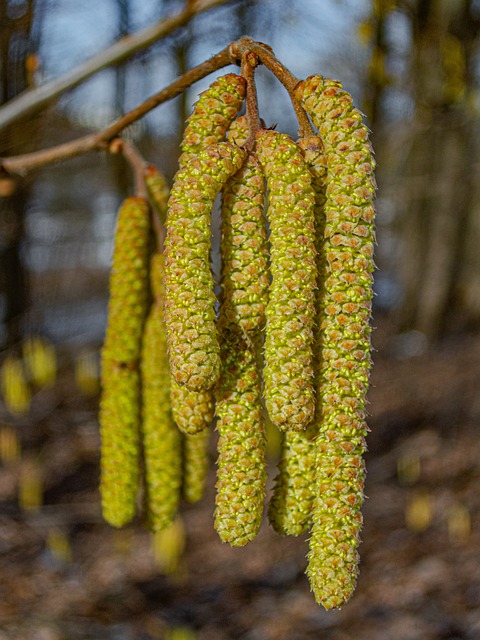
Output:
[230,37,314,137]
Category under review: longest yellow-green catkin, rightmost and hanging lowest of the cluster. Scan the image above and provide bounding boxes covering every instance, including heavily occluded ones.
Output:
[296,76,375,609]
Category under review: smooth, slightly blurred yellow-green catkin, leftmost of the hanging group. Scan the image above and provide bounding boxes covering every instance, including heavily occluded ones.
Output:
[99,197,150,527]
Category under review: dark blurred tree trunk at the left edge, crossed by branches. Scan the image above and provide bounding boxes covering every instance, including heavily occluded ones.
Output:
[0,0,38,344]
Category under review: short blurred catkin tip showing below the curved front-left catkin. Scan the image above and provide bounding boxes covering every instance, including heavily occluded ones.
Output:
[182,429,210,504]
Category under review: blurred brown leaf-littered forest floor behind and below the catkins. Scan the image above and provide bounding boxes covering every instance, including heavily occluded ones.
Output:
[0,316,480,640]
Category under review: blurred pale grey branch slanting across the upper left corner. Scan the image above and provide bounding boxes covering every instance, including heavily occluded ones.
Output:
[0,0,234,130]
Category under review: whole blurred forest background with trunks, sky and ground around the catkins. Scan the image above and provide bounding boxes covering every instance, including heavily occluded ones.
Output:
[0,0,480,640]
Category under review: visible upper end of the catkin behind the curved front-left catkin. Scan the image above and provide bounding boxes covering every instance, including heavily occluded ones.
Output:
[179,73,246,168]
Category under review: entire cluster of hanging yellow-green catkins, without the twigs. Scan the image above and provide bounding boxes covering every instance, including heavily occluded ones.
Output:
[100,73,375,609]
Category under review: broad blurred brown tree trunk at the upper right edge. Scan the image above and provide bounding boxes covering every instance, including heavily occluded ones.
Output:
[400,0,480,337]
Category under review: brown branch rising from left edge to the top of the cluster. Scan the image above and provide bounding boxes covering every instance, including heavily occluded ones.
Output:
[0,47,231,175]
